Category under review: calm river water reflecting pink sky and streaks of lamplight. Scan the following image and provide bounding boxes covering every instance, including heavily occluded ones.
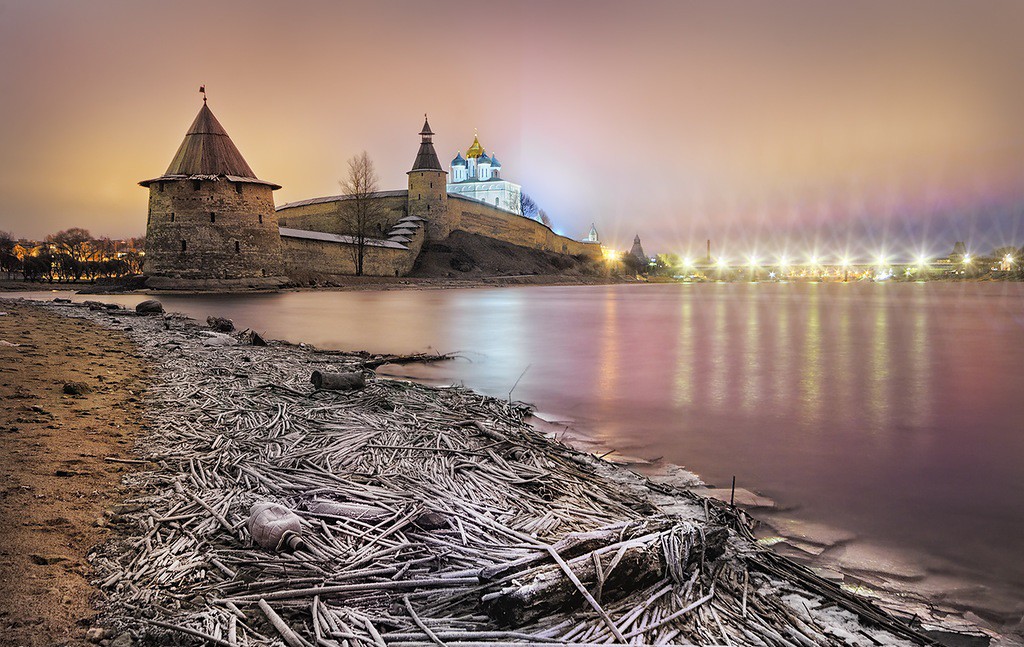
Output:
[14,284,1024,619]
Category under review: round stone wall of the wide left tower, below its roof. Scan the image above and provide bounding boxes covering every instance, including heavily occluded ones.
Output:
[143,178,284,281]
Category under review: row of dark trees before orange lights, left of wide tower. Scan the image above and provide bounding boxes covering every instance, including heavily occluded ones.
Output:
[0,227,144,283]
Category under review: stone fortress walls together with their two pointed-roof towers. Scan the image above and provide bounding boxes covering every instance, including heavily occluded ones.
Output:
[139,104,601,290]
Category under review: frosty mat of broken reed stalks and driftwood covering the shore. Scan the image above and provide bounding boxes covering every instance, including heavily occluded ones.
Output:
[37,305,950,647]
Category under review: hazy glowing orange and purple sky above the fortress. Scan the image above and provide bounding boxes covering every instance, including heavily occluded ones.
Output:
[0,0,1024,255]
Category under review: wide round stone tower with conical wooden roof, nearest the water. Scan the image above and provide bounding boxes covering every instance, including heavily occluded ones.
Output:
[139,98,287,289]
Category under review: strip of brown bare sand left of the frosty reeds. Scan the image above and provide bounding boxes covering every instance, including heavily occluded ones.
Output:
[0,300,146,645]
